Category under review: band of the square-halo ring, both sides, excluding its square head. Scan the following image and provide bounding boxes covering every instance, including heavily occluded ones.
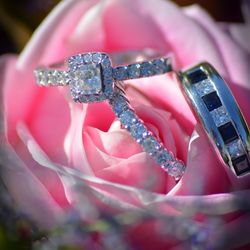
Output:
[35,49,172,86]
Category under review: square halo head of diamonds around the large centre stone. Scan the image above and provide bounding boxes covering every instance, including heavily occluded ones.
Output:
[68,52,113,103]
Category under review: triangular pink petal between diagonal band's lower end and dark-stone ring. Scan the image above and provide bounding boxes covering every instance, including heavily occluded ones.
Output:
[169,125,232,195]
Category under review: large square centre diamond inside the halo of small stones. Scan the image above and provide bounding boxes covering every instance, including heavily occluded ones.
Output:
[73,63,102,95]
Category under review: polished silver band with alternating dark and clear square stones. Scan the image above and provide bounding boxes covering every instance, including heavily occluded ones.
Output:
[179,63,250,177]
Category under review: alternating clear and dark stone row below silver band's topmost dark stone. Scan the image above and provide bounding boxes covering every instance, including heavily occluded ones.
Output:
[193,73,247,173]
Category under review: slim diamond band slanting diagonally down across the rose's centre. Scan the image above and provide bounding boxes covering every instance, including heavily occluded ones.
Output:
[110,91,185,180]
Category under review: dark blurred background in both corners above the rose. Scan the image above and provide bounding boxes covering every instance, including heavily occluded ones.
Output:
[0,0,246,54]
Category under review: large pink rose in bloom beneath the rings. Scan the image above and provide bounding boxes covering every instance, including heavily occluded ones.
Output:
[0,0,250,249]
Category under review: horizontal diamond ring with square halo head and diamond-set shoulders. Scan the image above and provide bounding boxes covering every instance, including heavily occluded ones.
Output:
[35,52,172,103]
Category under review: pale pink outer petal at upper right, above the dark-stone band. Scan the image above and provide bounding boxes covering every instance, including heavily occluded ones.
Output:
[186,6,250,87]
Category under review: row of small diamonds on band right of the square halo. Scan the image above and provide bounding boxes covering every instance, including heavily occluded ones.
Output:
[113,58,171,81]
